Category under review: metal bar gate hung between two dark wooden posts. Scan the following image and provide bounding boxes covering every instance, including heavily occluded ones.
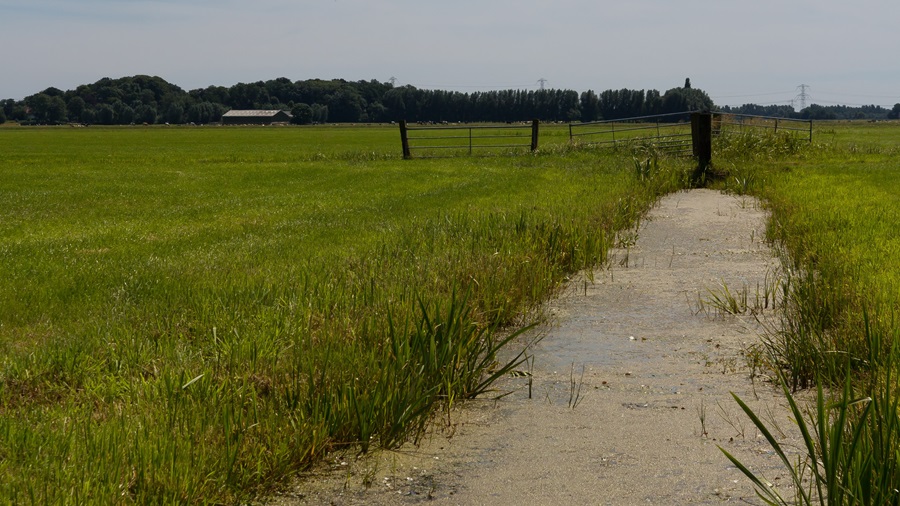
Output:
[400,120,539,158]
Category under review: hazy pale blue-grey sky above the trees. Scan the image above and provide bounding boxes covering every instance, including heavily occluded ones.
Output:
[0,0,900,109]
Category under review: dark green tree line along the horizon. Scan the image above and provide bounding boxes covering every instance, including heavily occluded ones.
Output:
[0,75,900,125]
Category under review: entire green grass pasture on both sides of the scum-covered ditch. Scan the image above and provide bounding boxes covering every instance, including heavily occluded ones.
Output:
[0,122,900,504]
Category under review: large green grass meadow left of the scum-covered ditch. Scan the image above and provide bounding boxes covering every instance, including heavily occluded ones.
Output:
[0,127,690,504]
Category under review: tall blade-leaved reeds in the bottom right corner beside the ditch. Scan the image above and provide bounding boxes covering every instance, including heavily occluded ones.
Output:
[722,322,900,505]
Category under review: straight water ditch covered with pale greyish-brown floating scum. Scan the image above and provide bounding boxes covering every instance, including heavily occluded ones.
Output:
[275,190,789,506]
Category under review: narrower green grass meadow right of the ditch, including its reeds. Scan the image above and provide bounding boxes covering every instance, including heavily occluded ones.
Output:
[719,123,900,505]
